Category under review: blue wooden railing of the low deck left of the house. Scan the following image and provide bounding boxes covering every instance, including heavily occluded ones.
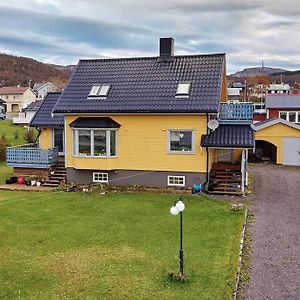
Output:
[6,145,58,169]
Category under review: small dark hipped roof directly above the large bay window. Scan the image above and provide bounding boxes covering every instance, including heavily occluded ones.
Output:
[70,117,121,128]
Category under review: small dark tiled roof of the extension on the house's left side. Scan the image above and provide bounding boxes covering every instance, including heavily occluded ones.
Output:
[29,93,64,128]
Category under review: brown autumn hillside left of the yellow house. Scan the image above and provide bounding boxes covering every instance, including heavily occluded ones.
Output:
[0,54,71,88]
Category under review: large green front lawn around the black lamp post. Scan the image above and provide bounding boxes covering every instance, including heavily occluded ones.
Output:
[0,191,243,300]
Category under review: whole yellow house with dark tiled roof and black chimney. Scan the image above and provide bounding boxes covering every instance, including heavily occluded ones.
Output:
[7,38,254,193]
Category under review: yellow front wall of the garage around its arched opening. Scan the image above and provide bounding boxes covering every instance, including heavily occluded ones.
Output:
[255,124,300,164]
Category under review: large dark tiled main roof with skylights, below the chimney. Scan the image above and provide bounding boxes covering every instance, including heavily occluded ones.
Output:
[54,54,225,113]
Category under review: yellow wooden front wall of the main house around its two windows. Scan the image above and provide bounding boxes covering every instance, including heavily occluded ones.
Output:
[66,115,206,172]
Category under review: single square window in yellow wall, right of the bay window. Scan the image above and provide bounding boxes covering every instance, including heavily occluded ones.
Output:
[168,130,194,153]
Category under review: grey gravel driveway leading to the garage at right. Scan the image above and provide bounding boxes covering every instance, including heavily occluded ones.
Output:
[245,164,300,300]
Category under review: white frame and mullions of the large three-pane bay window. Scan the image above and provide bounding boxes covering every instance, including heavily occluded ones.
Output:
[73,128,118,158]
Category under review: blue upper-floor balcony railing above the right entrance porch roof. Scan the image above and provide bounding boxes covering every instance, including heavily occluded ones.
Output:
[219,102,254,124]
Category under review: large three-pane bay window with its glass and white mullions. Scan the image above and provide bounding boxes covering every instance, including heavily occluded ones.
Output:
[73,129,117,157]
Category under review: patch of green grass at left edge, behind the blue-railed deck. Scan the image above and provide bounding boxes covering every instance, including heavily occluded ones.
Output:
[0,120,27,146]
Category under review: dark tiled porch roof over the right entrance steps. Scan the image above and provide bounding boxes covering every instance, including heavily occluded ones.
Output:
[201,124,255,148]
